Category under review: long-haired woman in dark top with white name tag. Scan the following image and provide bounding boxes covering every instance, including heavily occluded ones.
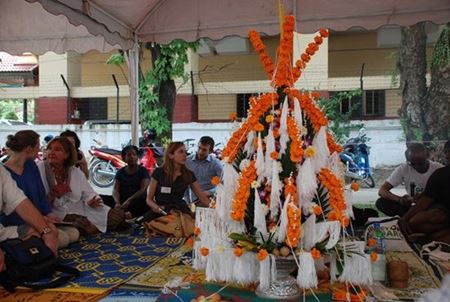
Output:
[146,142,213,220]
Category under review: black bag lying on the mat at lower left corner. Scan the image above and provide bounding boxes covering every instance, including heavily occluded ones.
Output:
[0,237,80,292]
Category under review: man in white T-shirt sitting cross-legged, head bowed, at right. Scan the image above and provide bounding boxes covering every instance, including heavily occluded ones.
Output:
[376,143,443,217]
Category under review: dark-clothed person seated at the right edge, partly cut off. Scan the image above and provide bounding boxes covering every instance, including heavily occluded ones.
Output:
[398,141,450,243]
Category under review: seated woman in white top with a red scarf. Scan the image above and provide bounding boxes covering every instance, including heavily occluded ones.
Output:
[38,136,124,234]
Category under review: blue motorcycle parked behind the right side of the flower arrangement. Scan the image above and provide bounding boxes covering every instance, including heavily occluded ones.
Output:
[339,129,375,188]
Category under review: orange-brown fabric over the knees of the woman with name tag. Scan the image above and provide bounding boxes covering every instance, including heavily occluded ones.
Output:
[144,209,195,238]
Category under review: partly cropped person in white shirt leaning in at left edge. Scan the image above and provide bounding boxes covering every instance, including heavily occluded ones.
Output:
[0,165,58,271]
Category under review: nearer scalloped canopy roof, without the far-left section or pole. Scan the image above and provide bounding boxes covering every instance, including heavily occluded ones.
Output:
[26,0,450,49]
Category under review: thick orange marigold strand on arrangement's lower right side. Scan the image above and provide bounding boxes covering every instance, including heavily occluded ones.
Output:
[318,168,350,227]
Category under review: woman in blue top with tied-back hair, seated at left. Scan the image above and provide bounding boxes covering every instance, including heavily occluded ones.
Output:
[1,130,80,248]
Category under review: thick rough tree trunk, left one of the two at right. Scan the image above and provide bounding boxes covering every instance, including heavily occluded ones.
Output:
[398,22,428,143]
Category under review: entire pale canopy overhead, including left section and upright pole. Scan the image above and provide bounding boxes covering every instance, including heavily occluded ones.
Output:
[0,0,450,143]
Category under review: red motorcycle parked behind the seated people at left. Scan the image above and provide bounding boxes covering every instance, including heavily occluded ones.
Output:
[88,140,163,188]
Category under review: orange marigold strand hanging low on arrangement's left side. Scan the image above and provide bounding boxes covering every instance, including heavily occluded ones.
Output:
[231,160,256,221]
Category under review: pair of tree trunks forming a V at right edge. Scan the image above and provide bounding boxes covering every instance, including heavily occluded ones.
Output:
[397,22,450,159]
